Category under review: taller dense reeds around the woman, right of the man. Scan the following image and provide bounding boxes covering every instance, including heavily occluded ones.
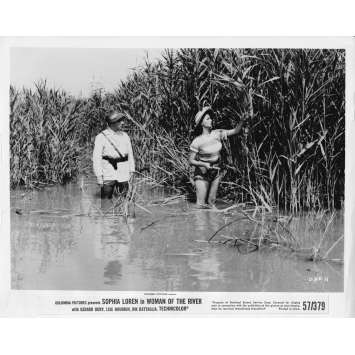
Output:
[110,49,345,213]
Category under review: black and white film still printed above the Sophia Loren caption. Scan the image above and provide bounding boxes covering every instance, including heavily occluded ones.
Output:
[9,41,346,292]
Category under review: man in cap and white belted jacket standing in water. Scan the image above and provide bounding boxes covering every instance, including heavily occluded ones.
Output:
[93,111,135,199]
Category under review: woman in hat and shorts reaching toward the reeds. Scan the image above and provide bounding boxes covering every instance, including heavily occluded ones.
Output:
[190,106,244,208]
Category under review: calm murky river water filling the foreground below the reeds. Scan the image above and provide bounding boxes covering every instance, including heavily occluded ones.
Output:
[11,178,343,292]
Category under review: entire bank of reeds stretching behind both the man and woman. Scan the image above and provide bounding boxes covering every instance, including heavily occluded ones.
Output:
[10,49,345,213]
